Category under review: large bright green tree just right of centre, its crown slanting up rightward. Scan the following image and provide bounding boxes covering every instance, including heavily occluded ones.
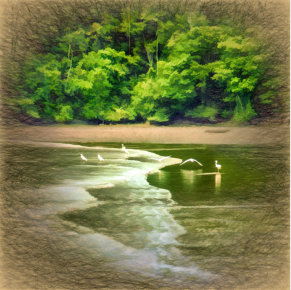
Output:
[133,25,225,121]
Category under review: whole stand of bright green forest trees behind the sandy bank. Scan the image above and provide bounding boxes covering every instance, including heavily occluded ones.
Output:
[2,0,290,123]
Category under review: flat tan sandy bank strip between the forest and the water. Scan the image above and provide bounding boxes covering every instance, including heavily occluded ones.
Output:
[2,124,289,145]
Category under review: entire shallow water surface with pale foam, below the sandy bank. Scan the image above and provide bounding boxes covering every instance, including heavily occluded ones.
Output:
[2,143,289,289]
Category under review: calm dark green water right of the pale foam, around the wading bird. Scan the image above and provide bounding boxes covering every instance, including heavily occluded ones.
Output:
[148,146,289,287]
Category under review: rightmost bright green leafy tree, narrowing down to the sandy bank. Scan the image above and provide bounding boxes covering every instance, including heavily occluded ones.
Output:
[212,36,265,122]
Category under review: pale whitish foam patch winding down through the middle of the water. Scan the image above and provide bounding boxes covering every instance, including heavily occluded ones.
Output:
[34,144,213,280]
